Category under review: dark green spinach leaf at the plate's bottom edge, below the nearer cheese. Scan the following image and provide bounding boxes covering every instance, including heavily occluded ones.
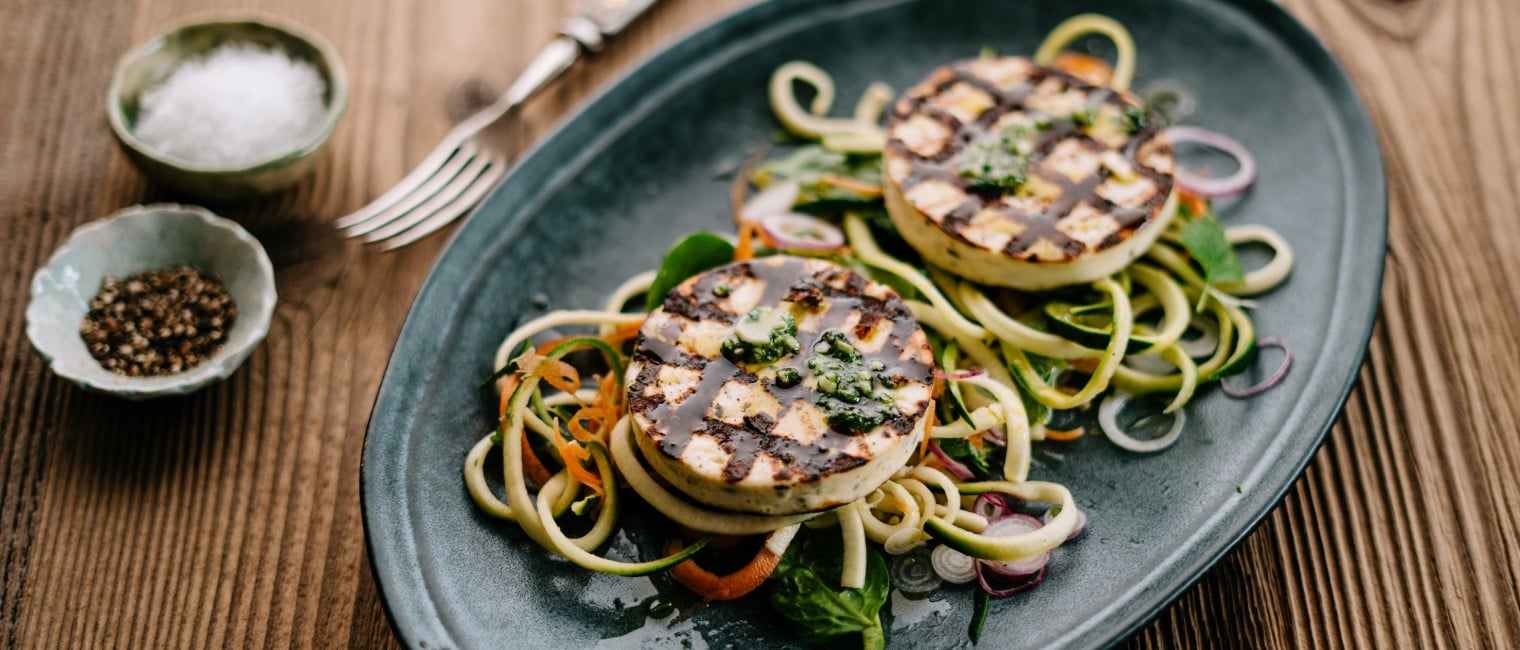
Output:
[771,535,891,648]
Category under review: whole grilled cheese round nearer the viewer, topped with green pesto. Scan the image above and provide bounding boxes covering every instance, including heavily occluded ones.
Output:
[628,257,933,515]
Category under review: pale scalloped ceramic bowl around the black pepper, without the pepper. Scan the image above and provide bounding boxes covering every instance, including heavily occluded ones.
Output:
[26,204,275,399]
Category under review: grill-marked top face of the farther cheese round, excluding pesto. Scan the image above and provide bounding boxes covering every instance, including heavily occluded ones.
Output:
[885,58,1173,263]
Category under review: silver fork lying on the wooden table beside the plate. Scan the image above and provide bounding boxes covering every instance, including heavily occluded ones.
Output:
[337,0,660,251]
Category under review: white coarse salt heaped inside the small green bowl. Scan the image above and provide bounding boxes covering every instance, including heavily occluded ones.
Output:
[134,43,327,167]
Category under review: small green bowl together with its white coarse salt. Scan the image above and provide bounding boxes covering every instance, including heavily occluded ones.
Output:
[106,14,348,199]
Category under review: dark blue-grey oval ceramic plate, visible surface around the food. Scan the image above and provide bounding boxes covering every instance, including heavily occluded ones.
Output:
[363,0,1386,648]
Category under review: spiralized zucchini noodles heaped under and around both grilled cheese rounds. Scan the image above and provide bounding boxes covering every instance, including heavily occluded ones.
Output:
[464,14,1294,625]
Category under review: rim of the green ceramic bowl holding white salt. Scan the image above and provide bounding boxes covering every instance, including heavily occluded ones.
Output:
[105,11,348,176]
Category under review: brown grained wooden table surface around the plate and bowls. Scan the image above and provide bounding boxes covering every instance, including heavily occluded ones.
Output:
[0,0,1520,648]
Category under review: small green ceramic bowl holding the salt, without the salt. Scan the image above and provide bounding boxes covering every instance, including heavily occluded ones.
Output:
[106,14,348,200]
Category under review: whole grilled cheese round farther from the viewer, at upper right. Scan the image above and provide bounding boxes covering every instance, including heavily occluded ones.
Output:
[883,58,1176,290]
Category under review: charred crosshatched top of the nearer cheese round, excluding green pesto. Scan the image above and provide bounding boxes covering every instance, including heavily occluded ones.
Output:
[628,257,933,510]
